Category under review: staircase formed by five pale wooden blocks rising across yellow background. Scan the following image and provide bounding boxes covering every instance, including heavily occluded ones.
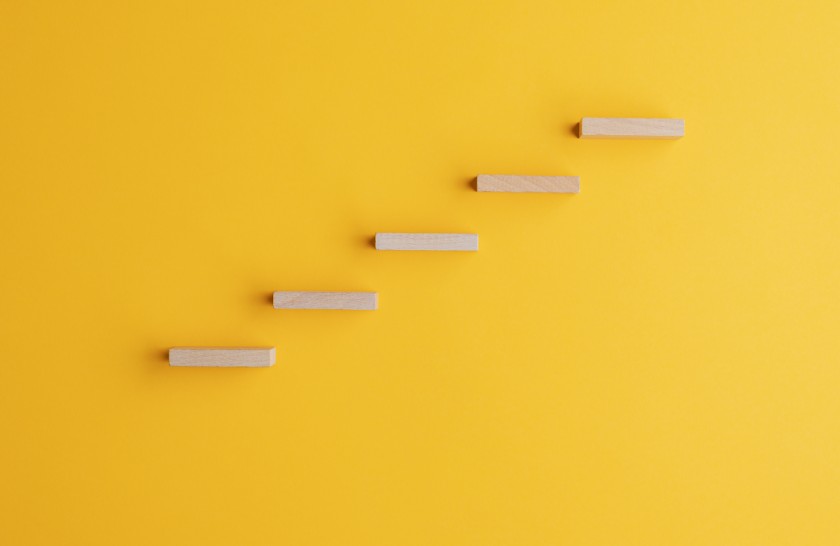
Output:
[169,118,685,368]
